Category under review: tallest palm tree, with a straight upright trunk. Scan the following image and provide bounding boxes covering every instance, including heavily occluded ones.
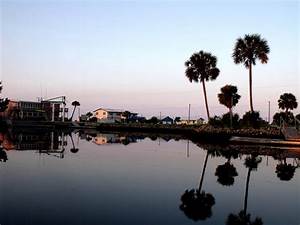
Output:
[232,34,270,112]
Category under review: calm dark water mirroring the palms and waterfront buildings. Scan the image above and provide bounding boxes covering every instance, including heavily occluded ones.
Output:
[0,131,300,225]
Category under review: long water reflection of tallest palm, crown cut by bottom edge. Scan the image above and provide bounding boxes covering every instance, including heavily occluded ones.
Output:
[226,154,263,225]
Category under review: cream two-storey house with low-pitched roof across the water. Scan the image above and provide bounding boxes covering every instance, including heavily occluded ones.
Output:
[93,108,123,123]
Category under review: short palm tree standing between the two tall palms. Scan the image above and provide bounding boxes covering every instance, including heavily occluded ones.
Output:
[218,84,241,116]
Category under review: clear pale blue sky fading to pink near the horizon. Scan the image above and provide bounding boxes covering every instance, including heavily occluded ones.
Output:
[0,0,300,119]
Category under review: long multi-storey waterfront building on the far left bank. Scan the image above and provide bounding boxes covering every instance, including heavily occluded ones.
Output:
[0,97,68,121]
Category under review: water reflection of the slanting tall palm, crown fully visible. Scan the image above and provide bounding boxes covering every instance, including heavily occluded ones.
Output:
[179,150,215,221]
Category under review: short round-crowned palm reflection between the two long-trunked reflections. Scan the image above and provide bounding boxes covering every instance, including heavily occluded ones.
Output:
[215,150,238,186]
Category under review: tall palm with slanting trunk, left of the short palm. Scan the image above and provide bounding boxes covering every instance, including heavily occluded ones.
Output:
[185,51,220,119]
